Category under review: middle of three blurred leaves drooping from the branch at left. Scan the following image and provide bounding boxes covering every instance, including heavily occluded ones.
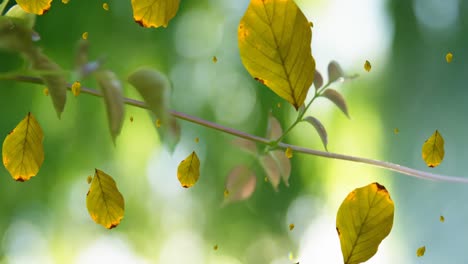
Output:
[96,71,125,144]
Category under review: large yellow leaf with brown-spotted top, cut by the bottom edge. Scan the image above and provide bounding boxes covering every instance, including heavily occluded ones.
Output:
[336,183,395,264]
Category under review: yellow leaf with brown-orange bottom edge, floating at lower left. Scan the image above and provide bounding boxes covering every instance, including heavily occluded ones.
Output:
[86,169,125,229]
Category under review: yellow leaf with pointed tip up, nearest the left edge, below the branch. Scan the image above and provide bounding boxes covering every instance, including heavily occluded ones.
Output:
[2,113,44,181]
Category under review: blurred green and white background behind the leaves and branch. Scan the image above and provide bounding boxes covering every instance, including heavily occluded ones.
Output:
[0,0,468,264]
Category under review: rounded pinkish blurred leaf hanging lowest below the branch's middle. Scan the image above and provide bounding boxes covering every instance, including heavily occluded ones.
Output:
[224,166,257,203]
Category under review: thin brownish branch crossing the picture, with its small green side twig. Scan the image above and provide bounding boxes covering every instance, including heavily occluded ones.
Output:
[0,75,468,183]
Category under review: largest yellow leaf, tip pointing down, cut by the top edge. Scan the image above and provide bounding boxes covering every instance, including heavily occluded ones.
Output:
[237,0,315,110]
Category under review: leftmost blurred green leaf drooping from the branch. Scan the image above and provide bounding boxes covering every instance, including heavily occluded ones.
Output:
[31,51,67,119]
